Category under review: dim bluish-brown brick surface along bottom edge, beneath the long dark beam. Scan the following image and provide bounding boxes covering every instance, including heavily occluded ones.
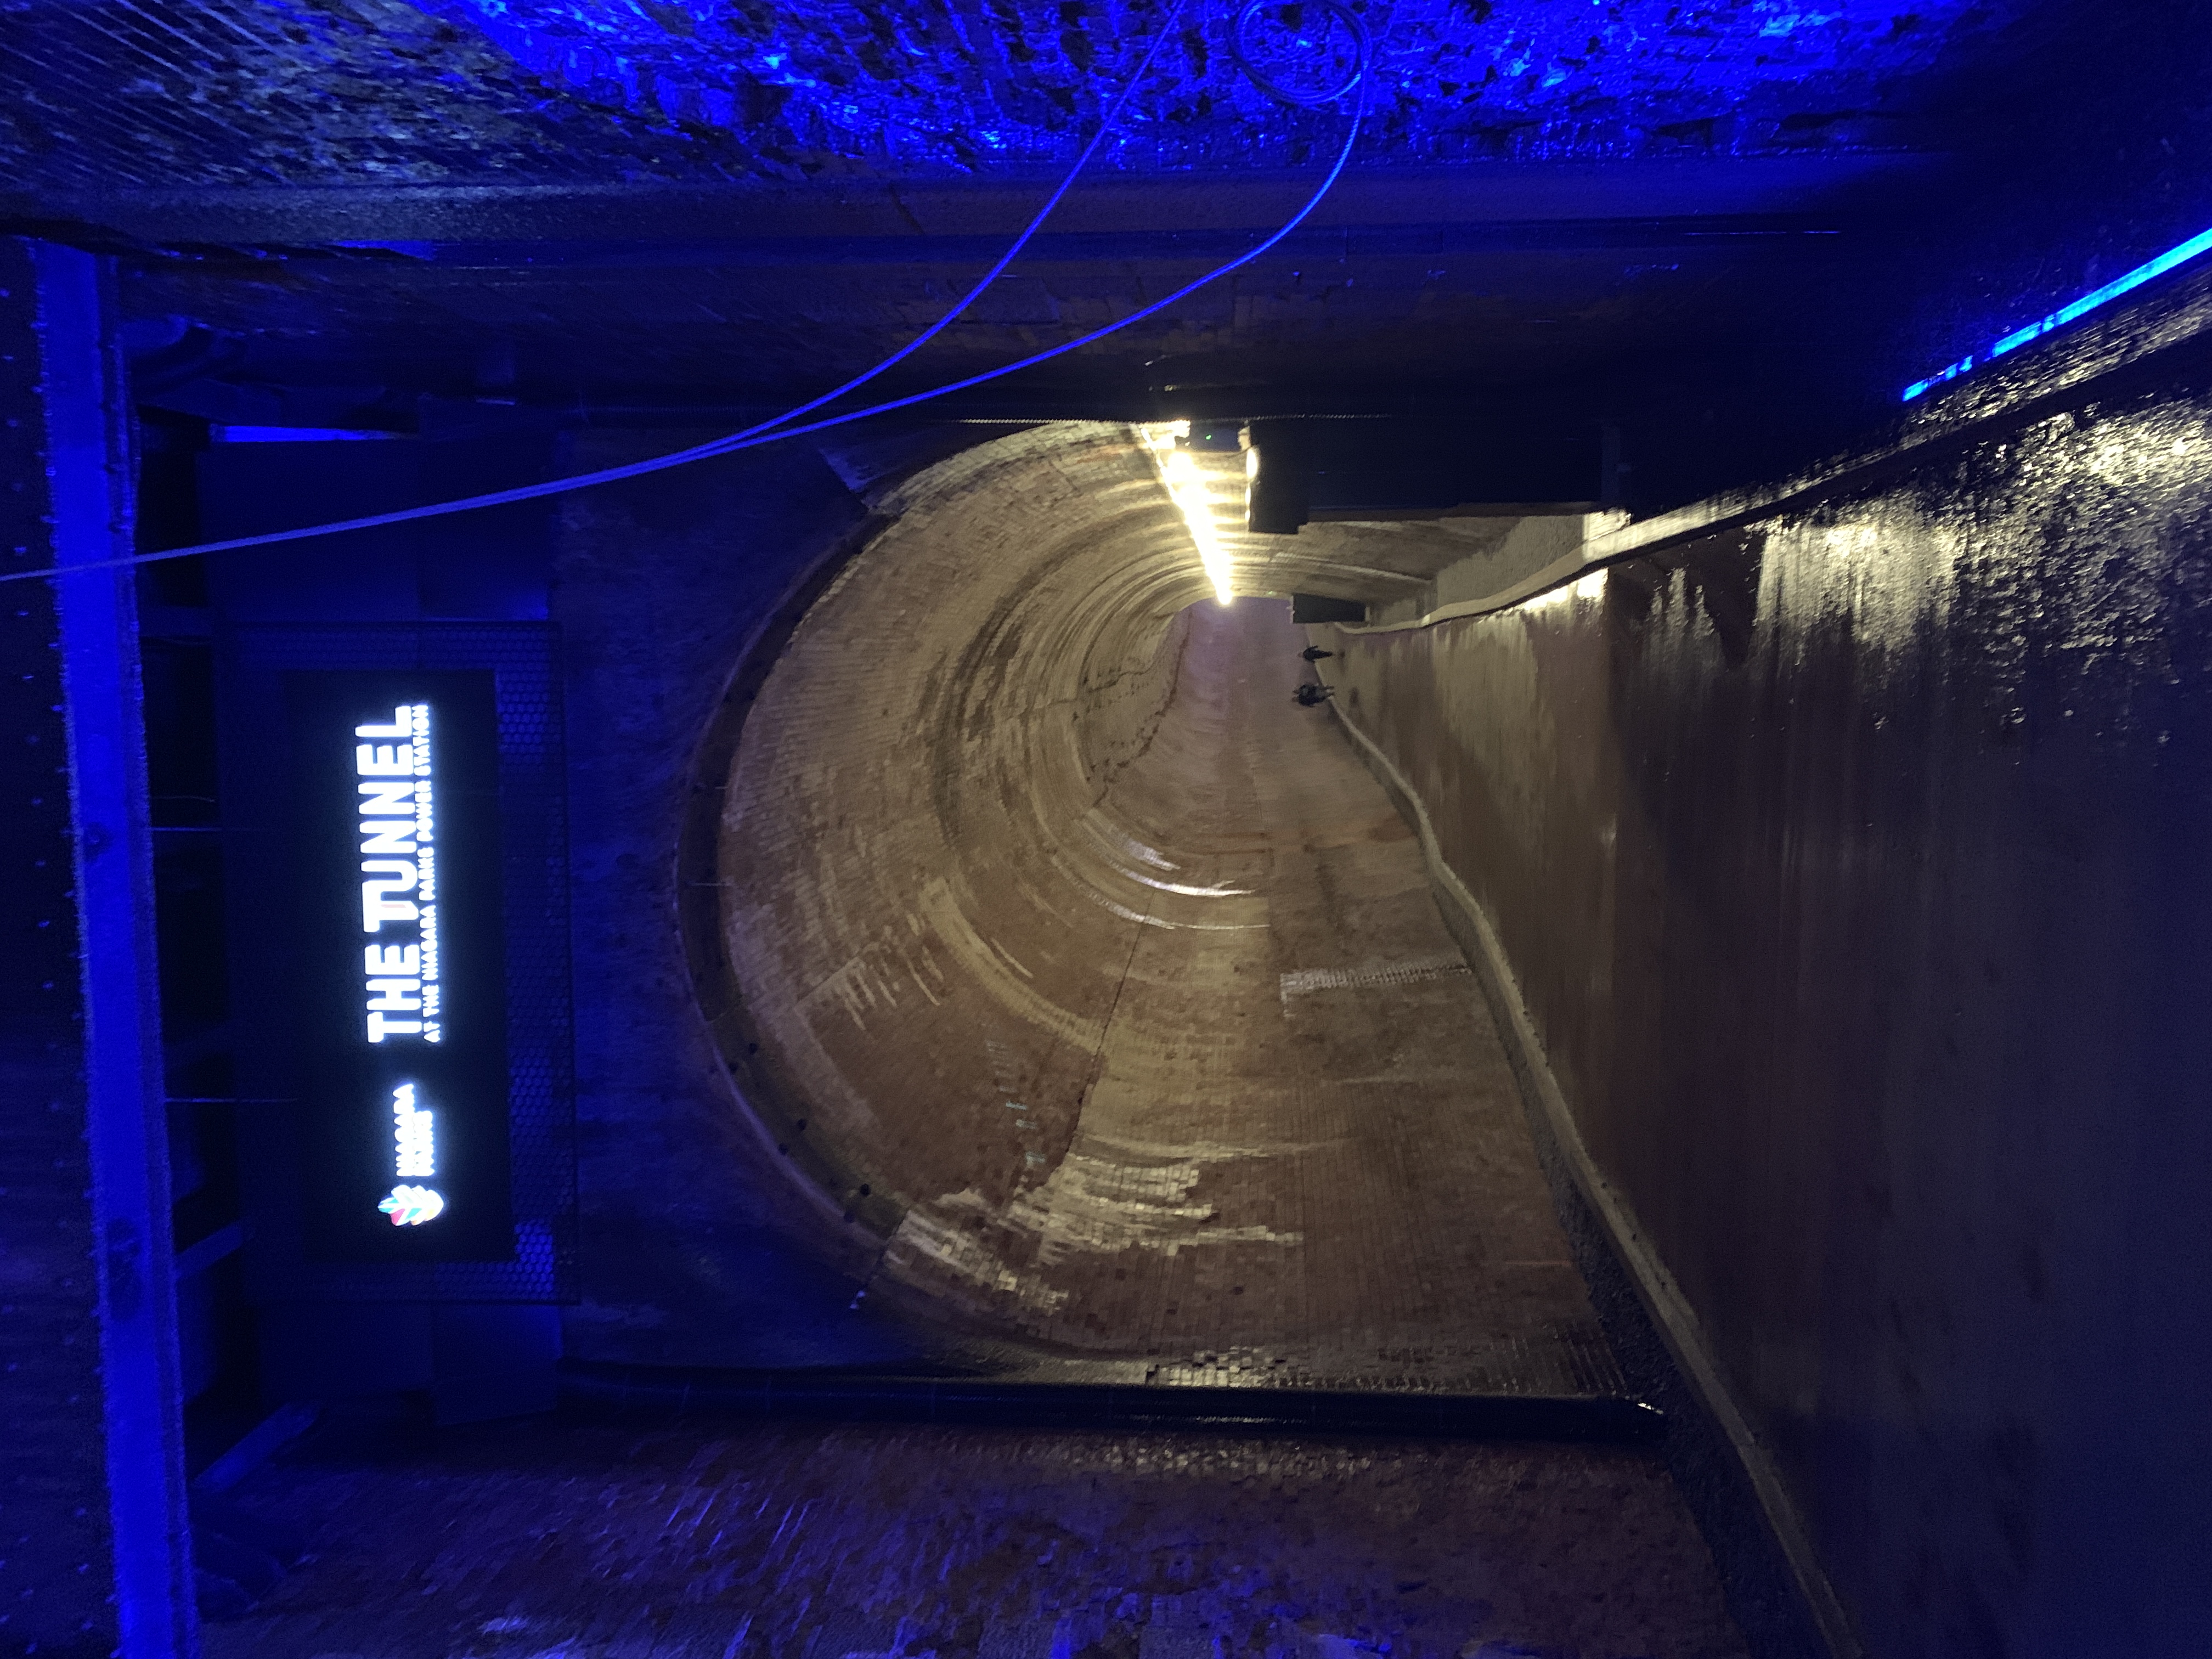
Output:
[204,1420,1745,1659]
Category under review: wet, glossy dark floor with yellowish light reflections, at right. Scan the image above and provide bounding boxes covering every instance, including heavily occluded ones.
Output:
[1314,319,2212,1659]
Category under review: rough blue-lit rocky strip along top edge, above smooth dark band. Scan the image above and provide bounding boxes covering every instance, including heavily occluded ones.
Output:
[0,0,2033,190]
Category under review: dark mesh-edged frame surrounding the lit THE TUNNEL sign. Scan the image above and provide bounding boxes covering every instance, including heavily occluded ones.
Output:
[217,622,579,1303]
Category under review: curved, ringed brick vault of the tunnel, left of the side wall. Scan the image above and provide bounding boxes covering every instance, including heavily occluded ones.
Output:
[716,425,1207,1316]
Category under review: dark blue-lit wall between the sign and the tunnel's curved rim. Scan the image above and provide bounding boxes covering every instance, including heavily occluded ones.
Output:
[551,422,900,1365]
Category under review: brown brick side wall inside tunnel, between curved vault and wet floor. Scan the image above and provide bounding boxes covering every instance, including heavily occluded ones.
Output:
[867,600,1621,1396]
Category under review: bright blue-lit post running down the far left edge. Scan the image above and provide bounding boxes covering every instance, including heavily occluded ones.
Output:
[18,244,197,1659]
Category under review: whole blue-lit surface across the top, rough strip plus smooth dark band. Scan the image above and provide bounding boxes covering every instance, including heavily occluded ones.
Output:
[0,0,2141,506]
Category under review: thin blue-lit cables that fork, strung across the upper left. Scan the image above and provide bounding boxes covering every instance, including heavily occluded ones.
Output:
[0,13,1367,582]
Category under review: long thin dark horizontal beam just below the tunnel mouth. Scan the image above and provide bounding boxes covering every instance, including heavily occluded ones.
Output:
[560,1361,1666,1444]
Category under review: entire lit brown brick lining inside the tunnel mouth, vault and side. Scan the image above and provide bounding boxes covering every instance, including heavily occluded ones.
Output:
[699,427,1612,1396]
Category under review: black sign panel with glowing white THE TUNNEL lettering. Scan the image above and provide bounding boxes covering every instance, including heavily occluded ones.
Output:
[285,670,513,1261]
